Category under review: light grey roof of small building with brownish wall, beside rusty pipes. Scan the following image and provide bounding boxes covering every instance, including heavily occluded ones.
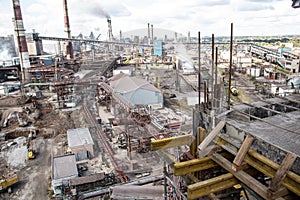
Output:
[67,128,94,148]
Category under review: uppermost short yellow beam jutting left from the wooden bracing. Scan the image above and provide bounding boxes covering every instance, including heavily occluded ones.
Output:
[151,134,194,151]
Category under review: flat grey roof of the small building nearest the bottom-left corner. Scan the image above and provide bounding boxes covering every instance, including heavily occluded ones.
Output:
[52,154,78,180]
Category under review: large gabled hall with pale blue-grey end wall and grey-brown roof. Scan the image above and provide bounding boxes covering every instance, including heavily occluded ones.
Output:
[110,74,163,109]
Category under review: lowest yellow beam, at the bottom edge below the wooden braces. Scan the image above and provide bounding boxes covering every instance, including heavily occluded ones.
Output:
[187,173,239,199]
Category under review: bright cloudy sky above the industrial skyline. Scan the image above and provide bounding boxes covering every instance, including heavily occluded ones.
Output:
[0,0,300,39]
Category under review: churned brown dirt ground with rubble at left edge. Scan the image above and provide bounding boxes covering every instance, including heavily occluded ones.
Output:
[0,97,82,200]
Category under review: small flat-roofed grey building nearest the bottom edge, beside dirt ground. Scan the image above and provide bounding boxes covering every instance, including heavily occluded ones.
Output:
[52,154,78,195]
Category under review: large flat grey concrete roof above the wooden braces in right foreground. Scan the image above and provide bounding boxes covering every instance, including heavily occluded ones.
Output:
[225,95,300,156]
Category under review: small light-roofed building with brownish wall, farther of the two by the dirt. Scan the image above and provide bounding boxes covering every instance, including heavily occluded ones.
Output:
[67,128,95,161]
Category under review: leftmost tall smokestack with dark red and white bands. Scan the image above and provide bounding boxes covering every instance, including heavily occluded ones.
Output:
[12,0,31,83]
